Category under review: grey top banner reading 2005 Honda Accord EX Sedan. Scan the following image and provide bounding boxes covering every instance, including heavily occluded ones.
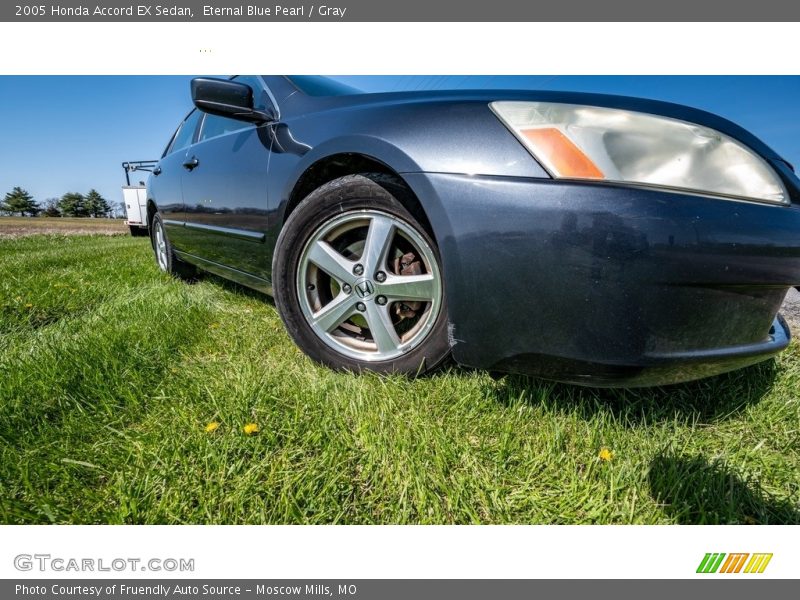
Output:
[0,0,800,21]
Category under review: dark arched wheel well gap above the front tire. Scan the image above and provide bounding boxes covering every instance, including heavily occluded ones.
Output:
[283,153,436,239]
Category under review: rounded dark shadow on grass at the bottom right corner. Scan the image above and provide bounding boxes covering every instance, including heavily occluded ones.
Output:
[648,453,800,525]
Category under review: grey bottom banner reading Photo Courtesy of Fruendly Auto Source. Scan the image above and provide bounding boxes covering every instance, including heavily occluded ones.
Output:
[0,580,797,600]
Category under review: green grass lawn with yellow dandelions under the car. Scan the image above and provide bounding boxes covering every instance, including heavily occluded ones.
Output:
[0,236,800,523]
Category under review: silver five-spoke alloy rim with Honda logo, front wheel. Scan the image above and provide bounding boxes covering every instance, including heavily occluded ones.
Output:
[297,210,442,362]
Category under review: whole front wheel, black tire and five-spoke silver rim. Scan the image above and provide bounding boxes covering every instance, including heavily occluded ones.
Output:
[273,174,450,374]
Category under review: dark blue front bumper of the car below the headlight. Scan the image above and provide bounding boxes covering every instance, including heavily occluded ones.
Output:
[403,173,800,387]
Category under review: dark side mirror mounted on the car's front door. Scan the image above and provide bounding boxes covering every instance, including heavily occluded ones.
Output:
[191,77,275,125]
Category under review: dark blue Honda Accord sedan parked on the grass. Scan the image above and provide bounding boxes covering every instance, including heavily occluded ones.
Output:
[147,76,800,386]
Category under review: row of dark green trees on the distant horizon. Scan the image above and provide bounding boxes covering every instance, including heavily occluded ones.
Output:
[0,187,114,217]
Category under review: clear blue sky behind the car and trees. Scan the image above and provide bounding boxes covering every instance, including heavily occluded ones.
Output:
[0,75,800,207]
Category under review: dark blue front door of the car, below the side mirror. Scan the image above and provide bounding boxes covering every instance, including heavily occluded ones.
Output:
[178,76,274,280]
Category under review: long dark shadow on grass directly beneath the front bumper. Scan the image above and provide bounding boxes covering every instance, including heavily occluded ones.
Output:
[494,359,778,427]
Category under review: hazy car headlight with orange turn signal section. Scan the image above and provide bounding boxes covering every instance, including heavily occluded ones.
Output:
[490,102,789,204]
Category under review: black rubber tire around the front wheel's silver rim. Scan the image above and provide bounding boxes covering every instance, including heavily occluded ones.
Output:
[272,174,450,375]
